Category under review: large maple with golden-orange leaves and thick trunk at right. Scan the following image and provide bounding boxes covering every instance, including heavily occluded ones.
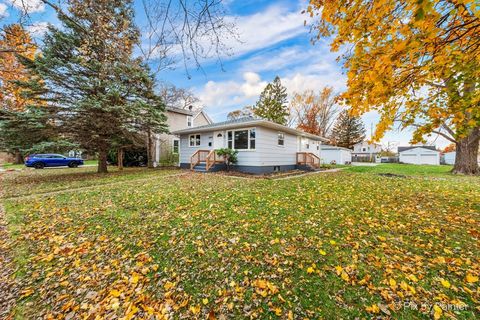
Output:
[307,0,480,174]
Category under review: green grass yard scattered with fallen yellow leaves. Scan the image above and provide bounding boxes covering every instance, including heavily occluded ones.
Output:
[0,165,480,319]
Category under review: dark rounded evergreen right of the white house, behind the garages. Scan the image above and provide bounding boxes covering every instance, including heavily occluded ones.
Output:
[330,110,365,149]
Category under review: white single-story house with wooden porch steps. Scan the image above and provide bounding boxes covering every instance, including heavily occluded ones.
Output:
[173,117,327,174]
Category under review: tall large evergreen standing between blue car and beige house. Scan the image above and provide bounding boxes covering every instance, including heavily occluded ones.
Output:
[26,0,165,172]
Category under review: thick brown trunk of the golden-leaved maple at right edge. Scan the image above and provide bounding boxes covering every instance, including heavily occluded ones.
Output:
[452,128,480,175]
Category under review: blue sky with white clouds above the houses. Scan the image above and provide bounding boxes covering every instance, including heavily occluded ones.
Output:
[0,0,448,147]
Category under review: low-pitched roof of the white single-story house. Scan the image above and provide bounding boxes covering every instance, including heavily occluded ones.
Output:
[172,116,327,141]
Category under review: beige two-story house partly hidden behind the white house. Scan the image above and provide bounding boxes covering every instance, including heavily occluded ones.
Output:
[154,107,212,166]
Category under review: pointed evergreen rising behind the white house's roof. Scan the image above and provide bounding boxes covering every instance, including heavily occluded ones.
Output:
[253,76,290,125]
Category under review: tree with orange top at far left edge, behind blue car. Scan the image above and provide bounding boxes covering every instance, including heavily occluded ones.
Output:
[0,24,52,164]
